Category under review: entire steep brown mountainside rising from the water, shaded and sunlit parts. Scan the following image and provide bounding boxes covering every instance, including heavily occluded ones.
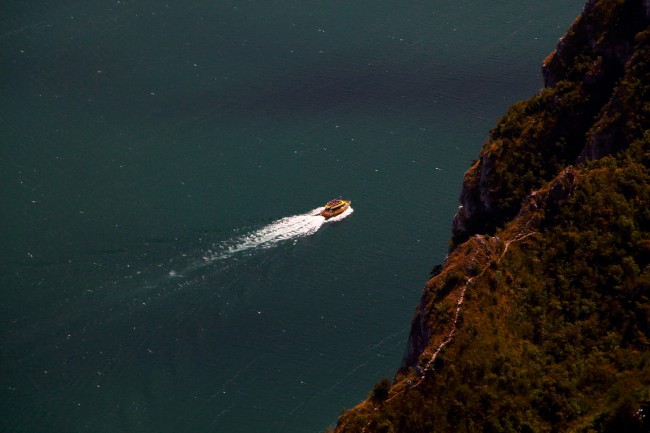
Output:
[336,0,650,432]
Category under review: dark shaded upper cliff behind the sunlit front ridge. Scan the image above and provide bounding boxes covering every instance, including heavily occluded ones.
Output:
[452,0,650,244]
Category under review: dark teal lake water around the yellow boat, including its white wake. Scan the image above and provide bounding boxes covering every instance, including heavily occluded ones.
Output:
[0,0,582,433]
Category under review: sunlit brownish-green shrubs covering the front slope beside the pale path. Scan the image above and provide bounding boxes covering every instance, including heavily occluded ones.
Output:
[334,141,650,432]
